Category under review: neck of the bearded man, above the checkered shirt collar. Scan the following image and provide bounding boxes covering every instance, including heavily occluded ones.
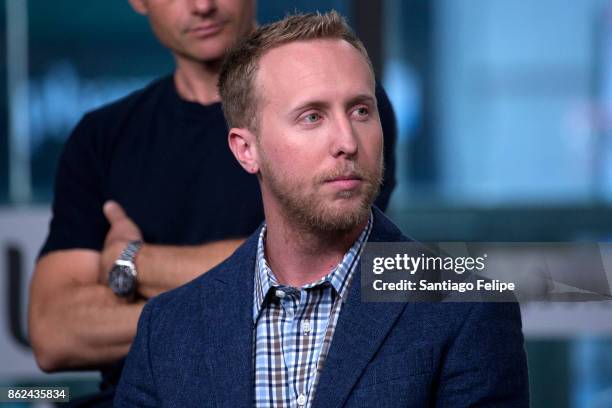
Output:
[265,207,368,287]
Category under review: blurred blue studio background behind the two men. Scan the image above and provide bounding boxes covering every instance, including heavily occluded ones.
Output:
[0,0,612,407]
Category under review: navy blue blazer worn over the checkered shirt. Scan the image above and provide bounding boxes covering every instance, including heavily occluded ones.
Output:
[115,209,529,408]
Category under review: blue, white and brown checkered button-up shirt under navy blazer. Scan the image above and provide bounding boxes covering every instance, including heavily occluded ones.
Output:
[253,214,372,408]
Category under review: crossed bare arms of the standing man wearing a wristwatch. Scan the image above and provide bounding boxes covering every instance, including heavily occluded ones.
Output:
[28,203,242,371]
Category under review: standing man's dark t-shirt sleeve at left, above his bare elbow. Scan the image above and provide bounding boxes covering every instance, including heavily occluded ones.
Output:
[39,114,109,257]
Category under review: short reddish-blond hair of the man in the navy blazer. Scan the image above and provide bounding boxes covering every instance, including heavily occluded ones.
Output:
[219,11,373,130]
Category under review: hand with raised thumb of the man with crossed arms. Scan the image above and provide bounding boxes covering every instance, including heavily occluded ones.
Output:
[98,201,142,285]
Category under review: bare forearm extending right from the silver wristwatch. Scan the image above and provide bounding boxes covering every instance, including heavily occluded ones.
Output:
[136,239,243,298]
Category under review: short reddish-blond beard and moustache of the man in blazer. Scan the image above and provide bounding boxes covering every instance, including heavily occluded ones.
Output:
[261,159,384,235]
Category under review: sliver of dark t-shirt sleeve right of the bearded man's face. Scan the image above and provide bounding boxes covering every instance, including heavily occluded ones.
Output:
[375,83,397,211]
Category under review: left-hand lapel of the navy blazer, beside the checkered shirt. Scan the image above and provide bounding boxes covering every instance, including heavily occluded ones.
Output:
[202,231,259,408]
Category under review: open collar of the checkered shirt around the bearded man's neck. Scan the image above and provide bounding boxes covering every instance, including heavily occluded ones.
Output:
[253,212,373,322]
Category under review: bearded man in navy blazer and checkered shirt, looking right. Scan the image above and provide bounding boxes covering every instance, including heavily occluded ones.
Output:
[115,12,529,408]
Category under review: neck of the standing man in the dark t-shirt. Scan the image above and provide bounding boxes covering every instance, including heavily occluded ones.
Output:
[174,57,221,105]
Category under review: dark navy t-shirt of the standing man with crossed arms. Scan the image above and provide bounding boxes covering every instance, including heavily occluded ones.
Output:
[41,76,396,396]
